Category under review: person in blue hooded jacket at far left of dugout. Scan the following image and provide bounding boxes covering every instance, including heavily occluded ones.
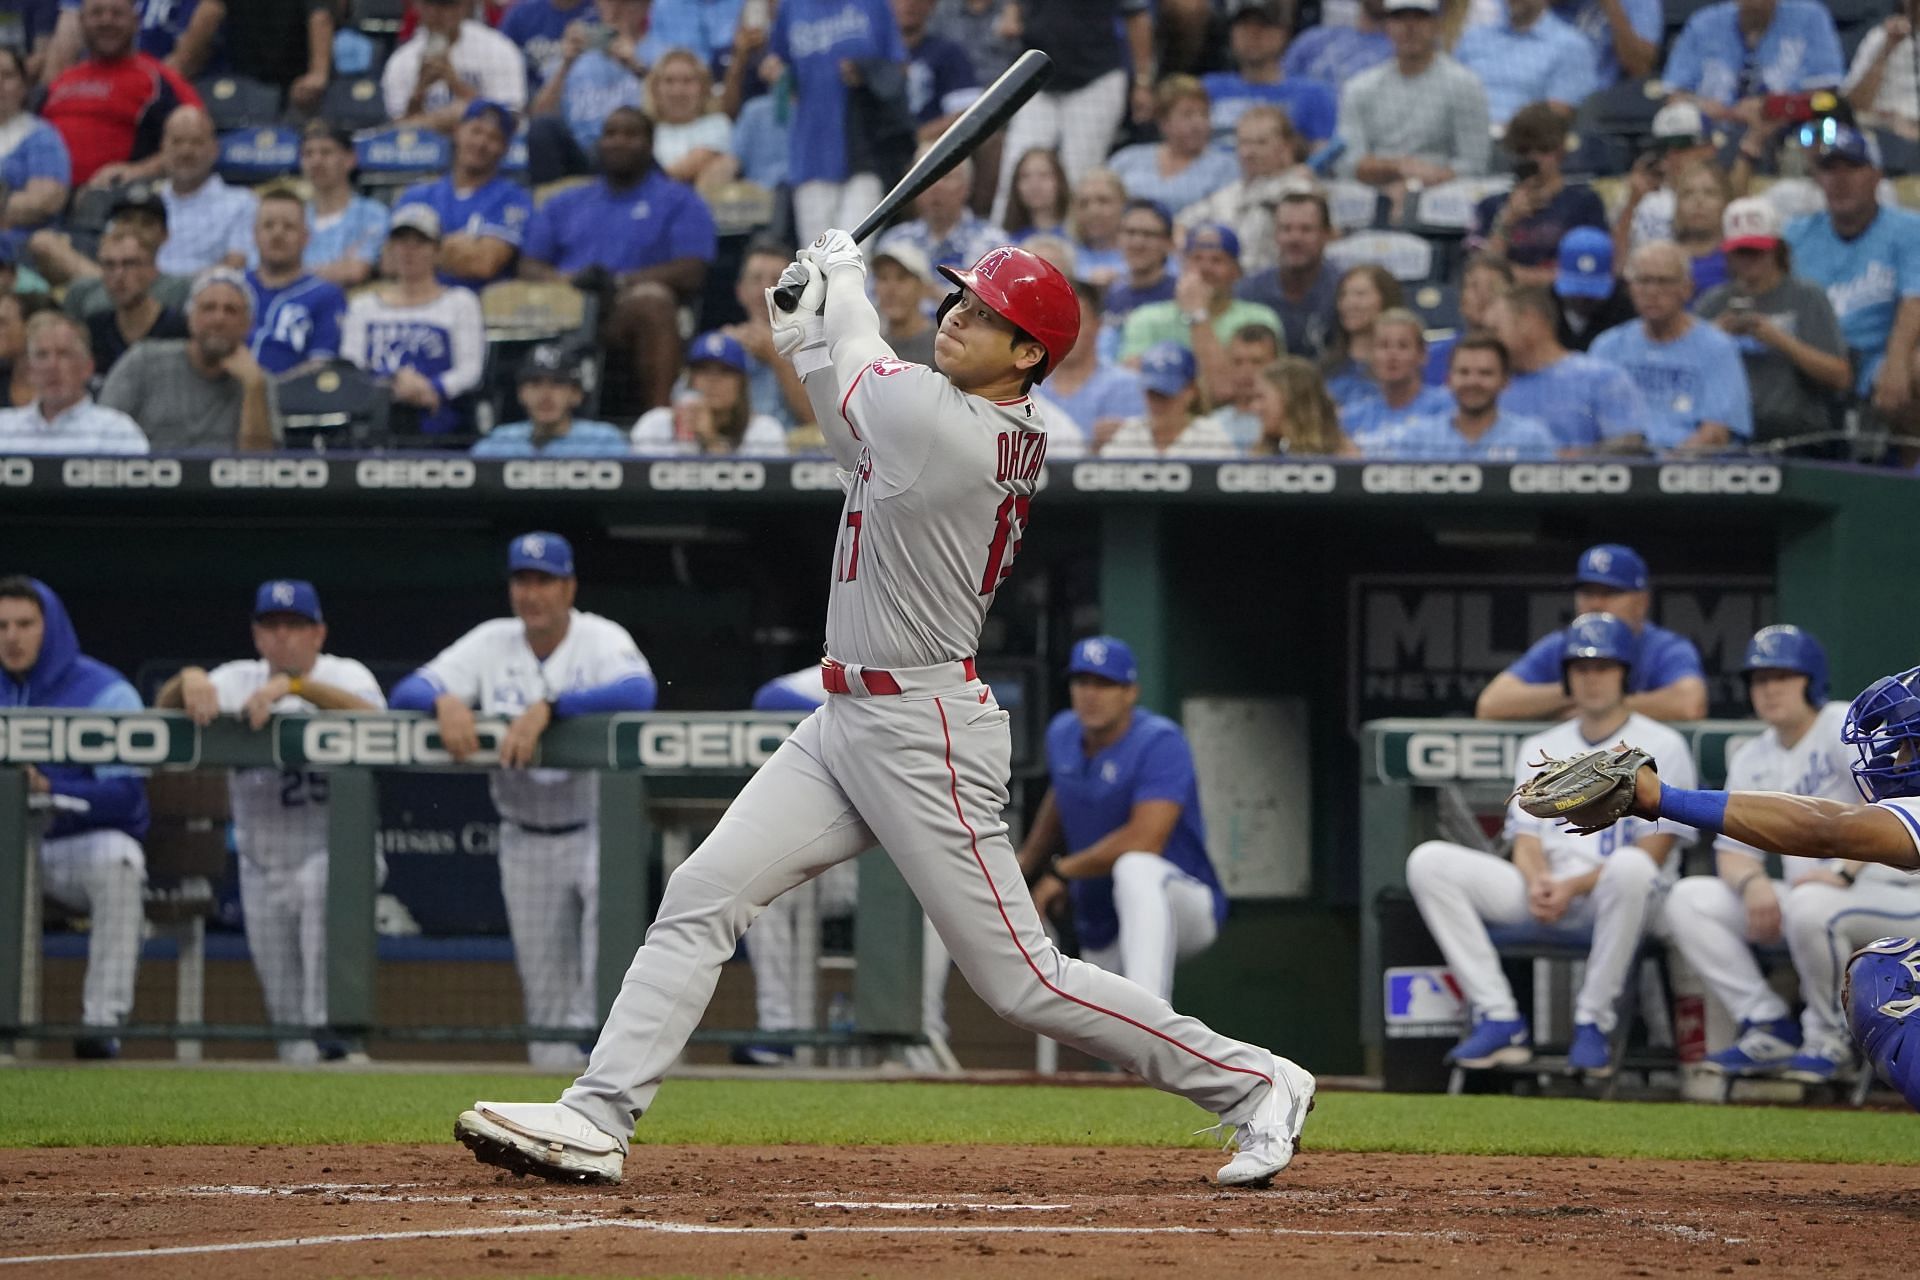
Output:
[0,574,148,1057]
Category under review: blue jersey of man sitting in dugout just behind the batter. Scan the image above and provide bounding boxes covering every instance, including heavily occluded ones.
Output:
[1046,710,1227,948]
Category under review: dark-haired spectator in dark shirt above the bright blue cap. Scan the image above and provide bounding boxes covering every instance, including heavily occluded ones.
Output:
[1469,102,1607,284]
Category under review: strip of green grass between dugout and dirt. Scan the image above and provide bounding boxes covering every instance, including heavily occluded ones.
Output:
[0,1067,1920,1165]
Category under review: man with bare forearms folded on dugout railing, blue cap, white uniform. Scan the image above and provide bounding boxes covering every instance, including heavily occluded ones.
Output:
[154,578,386,1063]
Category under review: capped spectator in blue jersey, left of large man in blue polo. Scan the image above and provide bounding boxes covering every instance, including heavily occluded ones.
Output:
[394,98,534,290]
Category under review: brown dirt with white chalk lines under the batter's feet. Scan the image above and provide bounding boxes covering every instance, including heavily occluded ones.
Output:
[0,1142,1896,1280]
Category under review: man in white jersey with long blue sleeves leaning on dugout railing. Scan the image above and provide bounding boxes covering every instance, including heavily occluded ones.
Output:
[390,532,657,1071]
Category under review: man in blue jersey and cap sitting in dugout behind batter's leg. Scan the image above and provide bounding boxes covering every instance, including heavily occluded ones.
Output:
[1020,635,1227,1000]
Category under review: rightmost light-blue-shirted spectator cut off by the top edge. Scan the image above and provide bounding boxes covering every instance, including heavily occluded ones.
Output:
[1661,0,1847,129]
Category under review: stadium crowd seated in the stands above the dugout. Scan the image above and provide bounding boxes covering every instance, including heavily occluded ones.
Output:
[0,0,1920,462]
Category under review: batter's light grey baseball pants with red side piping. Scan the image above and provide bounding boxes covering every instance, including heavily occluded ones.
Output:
[561,664,1271,1148]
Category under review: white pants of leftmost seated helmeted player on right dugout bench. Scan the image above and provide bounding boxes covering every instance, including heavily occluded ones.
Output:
[1407,841,1665,1032]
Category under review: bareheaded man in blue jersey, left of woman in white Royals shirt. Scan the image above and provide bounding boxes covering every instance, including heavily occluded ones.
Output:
[246,186,348,376]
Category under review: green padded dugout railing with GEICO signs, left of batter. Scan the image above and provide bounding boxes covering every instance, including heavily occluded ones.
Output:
[0,708,925,1048]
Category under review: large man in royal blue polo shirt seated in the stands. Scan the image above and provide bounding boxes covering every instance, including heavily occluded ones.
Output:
[520,107,718,418]
